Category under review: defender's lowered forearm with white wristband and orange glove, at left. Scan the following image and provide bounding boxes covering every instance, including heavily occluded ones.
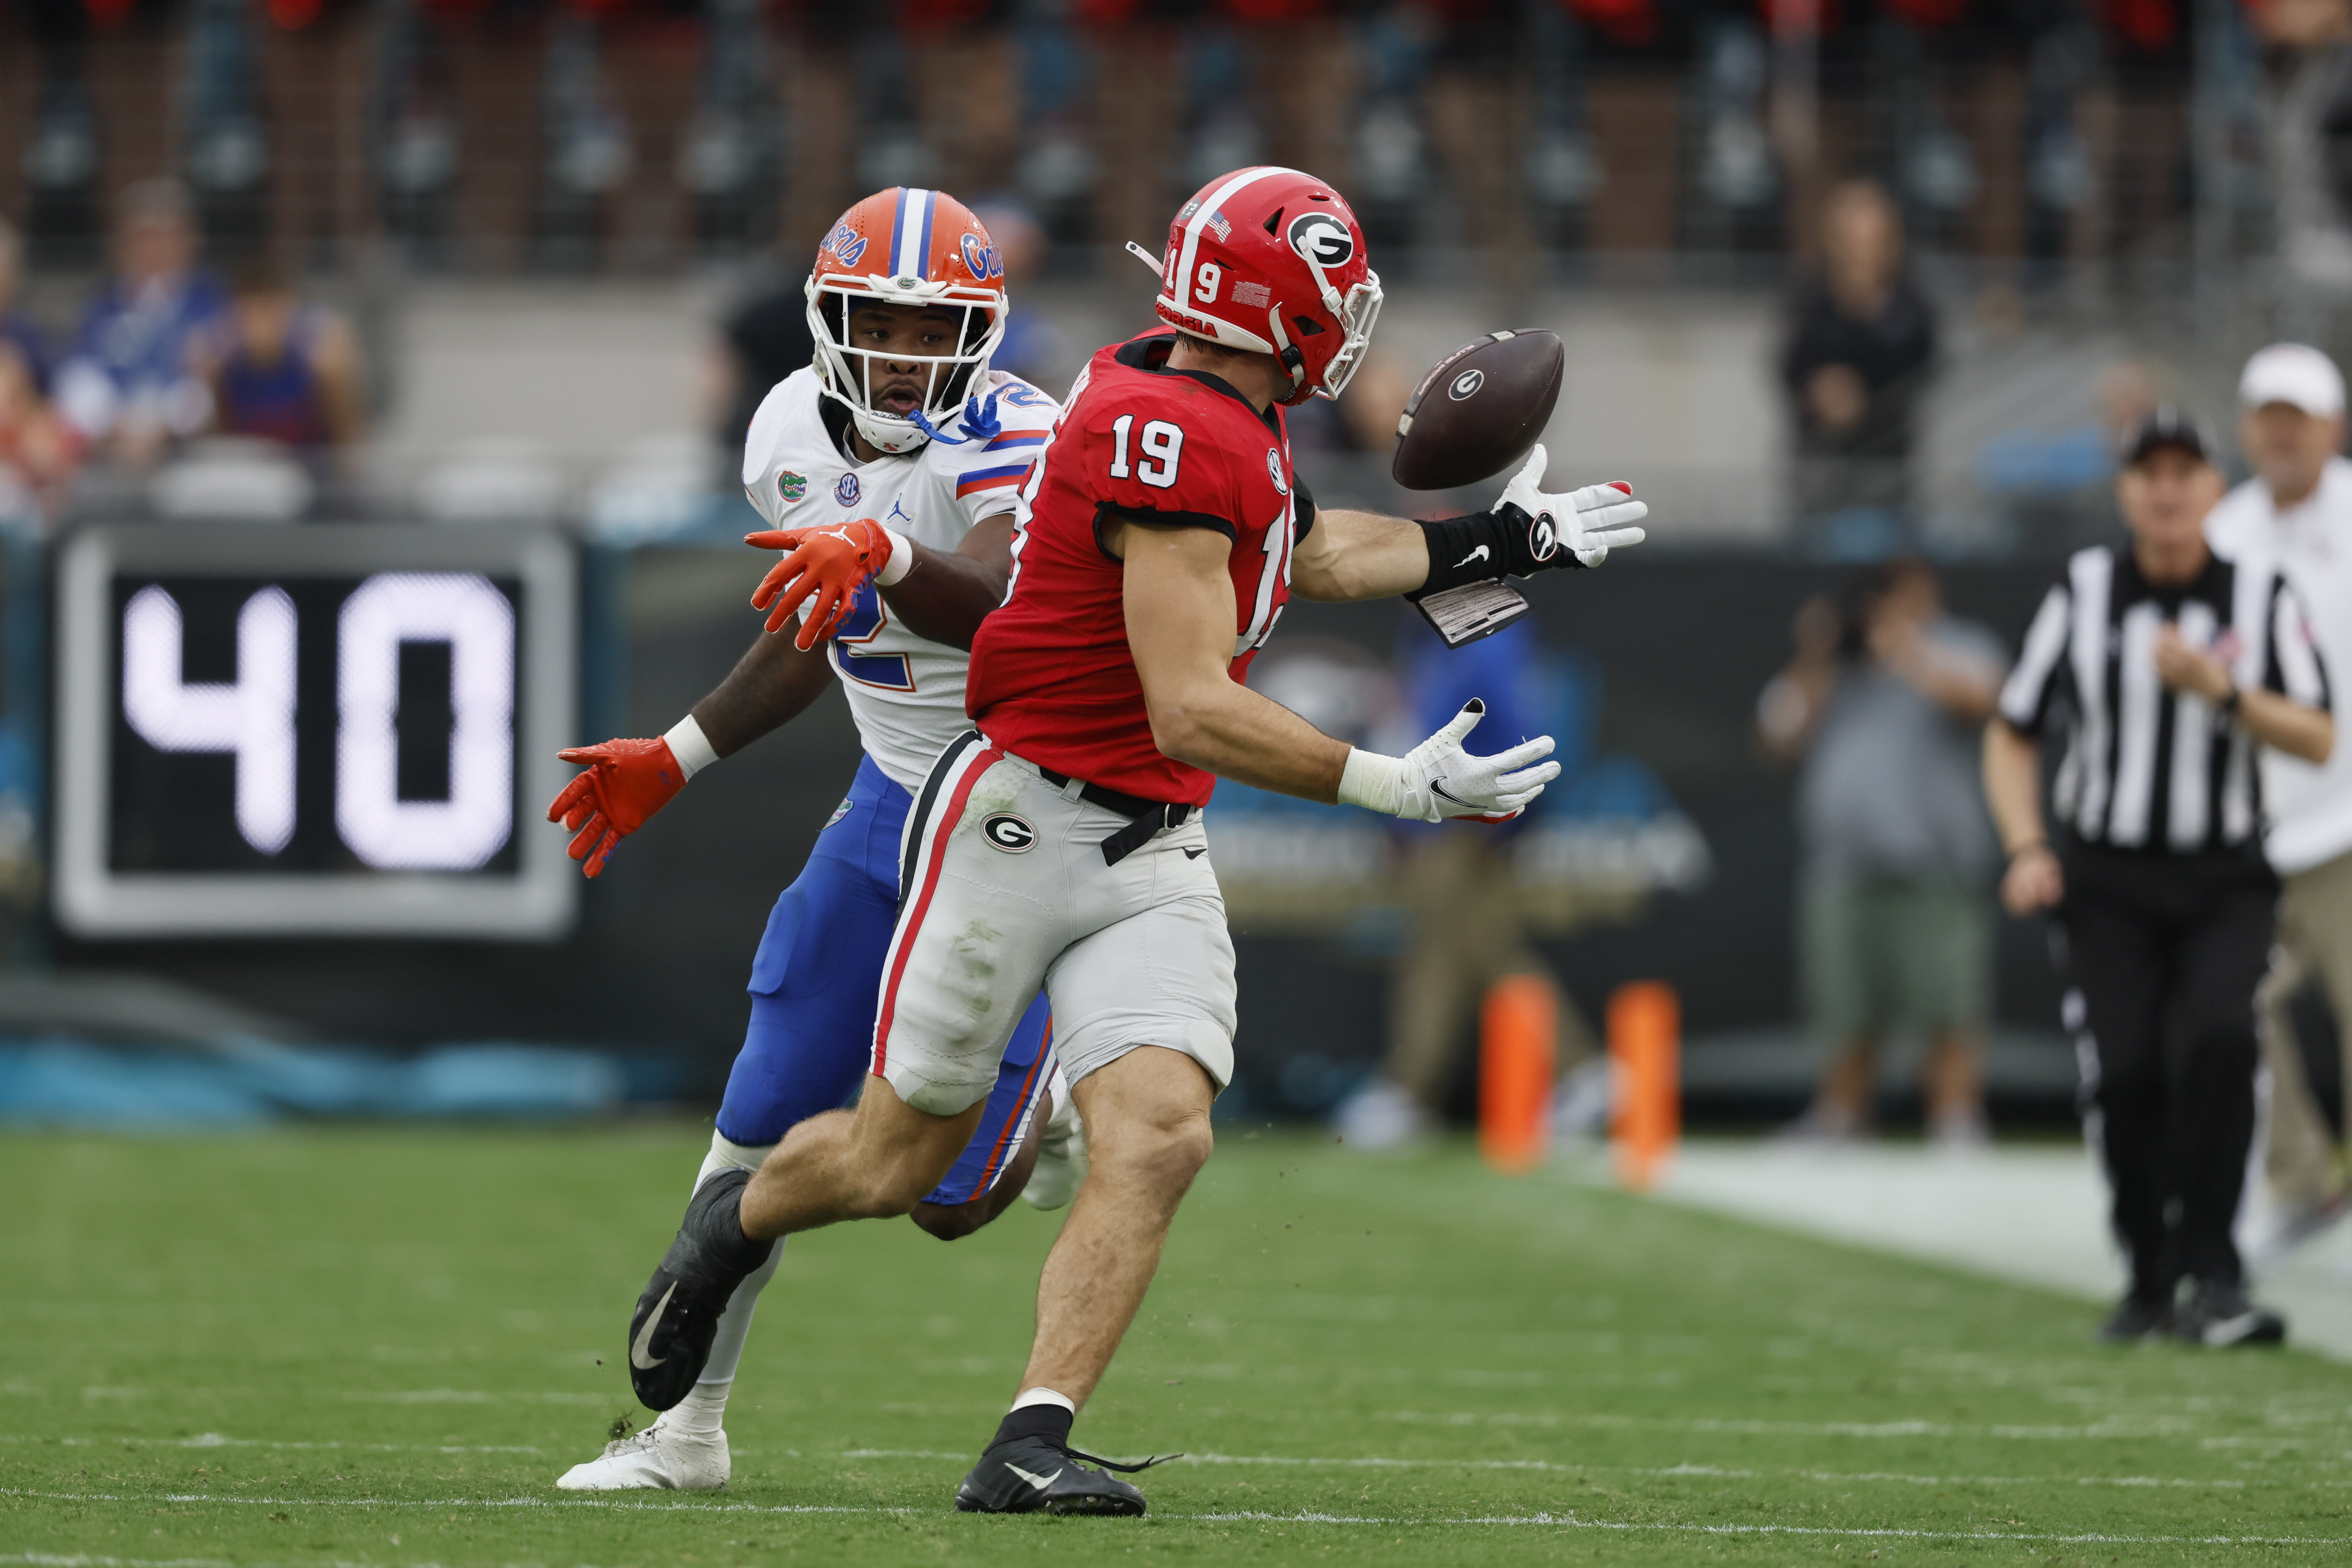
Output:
[548,635,833,877]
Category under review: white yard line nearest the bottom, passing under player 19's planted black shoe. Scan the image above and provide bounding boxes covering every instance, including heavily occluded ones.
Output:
[0,1486,2352,1547]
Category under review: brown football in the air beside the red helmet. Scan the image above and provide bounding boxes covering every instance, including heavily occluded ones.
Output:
[1388,327,1566,489]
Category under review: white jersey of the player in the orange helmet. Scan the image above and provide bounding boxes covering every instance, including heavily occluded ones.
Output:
[743,369,1061,792]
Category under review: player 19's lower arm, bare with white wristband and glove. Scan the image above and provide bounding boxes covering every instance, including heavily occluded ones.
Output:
[1115,522,1560,823]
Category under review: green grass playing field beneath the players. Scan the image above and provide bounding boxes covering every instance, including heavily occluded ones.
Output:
[0,1126,2352,1568]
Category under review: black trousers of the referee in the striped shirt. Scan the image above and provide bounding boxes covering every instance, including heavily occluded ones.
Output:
[2058,839,2279,1302]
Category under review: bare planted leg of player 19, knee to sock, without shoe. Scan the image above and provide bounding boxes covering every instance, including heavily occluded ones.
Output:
[1021,1046,1216,1408]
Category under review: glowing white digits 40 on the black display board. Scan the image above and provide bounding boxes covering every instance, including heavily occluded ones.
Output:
[120,571,517,872]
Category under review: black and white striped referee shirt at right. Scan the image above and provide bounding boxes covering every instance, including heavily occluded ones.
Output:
[2002,545,2328,854]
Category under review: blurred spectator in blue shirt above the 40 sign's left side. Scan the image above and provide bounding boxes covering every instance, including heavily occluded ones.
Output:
[56,179,226,468]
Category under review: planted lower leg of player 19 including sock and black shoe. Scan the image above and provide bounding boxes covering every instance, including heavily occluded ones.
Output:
[955,1046,1216,1514]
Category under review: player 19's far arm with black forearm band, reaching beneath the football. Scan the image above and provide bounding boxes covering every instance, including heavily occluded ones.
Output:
[1291,445,1649,599]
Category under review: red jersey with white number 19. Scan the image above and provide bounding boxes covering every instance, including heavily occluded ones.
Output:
[964,329,1315,806]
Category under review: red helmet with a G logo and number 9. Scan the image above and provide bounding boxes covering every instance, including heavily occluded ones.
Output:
[1145,165,1381,404]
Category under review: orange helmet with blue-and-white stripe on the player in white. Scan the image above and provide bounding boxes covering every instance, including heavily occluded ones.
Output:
[807,186,1004,451]
